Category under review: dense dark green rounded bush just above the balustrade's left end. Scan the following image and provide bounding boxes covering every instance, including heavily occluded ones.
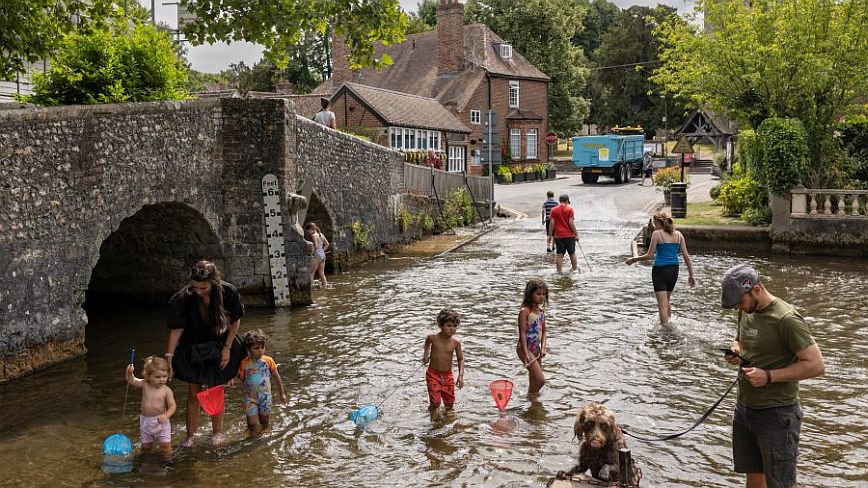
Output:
[752,117,808,193]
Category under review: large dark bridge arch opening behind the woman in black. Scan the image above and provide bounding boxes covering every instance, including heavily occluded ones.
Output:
[84,202,225,311]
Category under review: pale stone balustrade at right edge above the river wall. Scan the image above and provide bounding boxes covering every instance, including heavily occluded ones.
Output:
[790,188,868,219]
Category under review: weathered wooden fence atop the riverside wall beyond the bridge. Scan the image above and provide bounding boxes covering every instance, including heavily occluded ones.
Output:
[404,163,492,204]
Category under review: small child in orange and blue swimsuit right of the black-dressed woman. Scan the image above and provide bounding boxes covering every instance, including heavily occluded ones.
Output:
[238,329,286,436]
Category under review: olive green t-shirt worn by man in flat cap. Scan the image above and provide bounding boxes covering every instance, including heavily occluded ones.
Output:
[738,298,814,408]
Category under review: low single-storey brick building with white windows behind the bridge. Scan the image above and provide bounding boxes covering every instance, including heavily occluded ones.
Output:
[331,83,470,172]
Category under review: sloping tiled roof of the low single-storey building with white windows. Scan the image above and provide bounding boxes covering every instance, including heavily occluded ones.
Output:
[335,83,470,133]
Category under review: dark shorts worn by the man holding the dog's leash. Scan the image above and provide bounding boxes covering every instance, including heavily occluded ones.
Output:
[732,403,802,488]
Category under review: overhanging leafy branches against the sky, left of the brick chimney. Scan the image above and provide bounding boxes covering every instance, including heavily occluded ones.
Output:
[182,0,407,67]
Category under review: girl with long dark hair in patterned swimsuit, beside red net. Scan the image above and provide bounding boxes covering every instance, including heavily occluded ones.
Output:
[515,278,549,399]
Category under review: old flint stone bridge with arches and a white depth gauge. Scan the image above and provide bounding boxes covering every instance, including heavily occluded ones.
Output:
[0,99,404,381]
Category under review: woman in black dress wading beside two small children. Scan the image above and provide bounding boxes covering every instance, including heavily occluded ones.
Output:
[166,261,246,447]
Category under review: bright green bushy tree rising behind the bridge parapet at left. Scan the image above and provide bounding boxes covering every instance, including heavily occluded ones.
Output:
[24,22,188,105]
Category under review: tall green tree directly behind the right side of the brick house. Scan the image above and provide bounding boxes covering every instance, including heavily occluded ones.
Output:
[465,0,588,135]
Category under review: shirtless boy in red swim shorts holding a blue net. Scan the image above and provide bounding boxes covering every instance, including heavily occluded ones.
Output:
[422,309,464,414]
